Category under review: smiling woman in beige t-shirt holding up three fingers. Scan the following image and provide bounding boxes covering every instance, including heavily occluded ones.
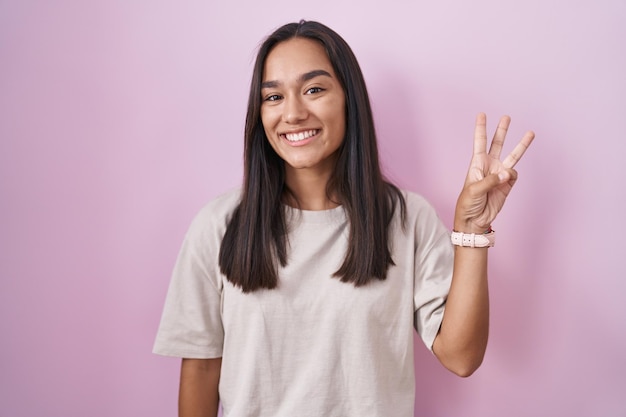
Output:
[154,21,534,417]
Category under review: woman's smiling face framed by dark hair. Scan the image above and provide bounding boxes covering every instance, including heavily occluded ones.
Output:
[261,38,346,176]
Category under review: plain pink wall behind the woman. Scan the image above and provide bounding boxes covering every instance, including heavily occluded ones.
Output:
[0,0,626,417]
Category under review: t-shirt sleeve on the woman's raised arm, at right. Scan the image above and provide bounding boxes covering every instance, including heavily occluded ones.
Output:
[413,196,454,351]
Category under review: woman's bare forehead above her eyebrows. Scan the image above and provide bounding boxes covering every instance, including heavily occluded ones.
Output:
[263,38,335,81]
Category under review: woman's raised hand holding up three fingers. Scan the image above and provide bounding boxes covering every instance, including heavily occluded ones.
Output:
[454,113,535,233]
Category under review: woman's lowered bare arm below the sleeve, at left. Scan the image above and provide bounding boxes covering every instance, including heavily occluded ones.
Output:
[178,358,222,417]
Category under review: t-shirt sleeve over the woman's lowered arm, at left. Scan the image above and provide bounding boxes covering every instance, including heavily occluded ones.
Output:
[153,208,224,359]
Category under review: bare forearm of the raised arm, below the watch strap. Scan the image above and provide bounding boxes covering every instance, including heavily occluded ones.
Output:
[433,247,489,376]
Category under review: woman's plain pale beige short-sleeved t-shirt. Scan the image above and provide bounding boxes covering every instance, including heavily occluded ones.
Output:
[154,190,453,417]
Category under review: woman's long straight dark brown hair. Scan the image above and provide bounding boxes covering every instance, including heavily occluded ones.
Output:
[219,21,406,292]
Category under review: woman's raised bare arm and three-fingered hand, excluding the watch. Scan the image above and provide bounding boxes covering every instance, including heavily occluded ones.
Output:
[433,113,535,377]
